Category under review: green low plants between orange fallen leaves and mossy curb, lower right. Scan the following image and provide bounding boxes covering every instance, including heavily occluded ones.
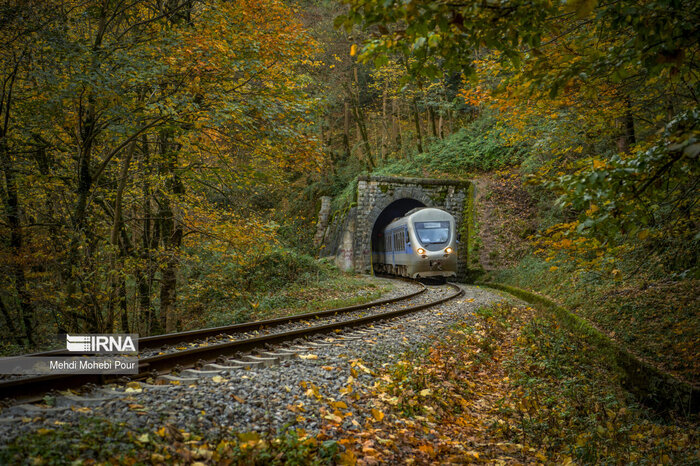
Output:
[501,310,699,464]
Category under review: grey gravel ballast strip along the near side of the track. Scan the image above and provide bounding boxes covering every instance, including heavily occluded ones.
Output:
[0,278,516,446]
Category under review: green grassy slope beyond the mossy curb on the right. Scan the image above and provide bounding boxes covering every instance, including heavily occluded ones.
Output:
[485,256,700,385]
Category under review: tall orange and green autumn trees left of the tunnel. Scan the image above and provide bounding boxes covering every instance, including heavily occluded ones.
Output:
[0,0,321,345]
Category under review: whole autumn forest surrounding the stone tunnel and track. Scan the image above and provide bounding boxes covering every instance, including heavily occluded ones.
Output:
[0,0,700,462]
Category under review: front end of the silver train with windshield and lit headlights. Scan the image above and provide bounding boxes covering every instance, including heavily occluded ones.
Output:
[408,208,457,278]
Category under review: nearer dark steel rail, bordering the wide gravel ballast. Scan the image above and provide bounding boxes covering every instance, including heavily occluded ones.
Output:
[0,283,463,401]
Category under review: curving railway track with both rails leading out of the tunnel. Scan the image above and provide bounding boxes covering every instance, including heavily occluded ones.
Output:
[0,284,462,402]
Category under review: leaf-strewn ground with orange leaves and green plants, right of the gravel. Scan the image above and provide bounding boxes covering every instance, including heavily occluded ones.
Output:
[330,303,700,464]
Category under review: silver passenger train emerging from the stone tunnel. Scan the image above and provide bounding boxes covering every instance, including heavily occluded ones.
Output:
[372,207,457,278]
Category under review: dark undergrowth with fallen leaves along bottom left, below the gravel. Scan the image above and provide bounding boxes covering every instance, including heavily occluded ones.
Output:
[0,418,338,465]
